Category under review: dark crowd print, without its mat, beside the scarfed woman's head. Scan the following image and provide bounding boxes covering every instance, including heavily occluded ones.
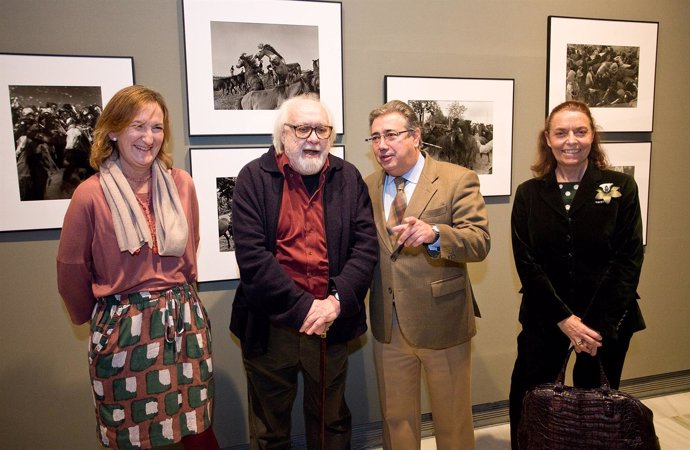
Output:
[9,85,103,201]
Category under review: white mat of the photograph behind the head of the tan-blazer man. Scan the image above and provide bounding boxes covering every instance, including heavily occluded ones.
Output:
[385,75,515,196]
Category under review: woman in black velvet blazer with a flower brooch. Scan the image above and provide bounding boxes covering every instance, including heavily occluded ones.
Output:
[510,101,645,449]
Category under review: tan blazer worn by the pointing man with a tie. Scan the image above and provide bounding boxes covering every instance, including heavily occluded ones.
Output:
[365,154,490,349]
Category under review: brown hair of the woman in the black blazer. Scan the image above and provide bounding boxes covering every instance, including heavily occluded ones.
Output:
[530,100,609,179]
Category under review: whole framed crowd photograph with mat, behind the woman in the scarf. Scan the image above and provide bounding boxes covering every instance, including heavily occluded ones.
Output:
[0,53,134,231]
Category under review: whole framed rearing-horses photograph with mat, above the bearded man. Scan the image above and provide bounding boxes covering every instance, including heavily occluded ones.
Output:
[183,0,343,136]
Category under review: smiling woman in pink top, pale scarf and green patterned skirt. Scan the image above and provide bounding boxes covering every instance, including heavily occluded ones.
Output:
[57,86,219,449]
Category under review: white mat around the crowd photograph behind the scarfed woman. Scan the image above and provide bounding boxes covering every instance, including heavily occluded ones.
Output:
[0,53,134,231]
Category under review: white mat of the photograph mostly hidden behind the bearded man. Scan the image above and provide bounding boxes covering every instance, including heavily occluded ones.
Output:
[190,145,345,282]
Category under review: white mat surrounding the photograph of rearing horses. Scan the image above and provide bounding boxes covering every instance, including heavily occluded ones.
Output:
[183,0,344,136]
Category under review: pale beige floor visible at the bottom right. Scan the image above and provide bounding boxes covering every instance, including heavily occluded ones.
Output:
[376,392,690,450]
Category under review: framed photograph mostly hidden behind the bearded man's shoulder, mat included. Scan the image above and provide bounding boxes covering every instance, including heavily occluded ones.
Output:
[190,145,345,281]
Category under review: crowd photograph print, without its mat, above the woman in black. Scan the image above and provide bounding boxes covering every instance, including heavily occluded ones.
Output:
[565,44,640,108]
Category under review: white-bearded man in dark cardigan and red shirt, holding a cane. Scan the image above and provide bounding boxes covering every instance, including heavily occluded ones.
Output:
[230,95,378,450]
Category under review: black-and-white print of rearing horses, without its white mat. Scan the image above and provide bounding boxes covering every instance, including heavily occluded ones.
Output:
[208,21,319,110]
